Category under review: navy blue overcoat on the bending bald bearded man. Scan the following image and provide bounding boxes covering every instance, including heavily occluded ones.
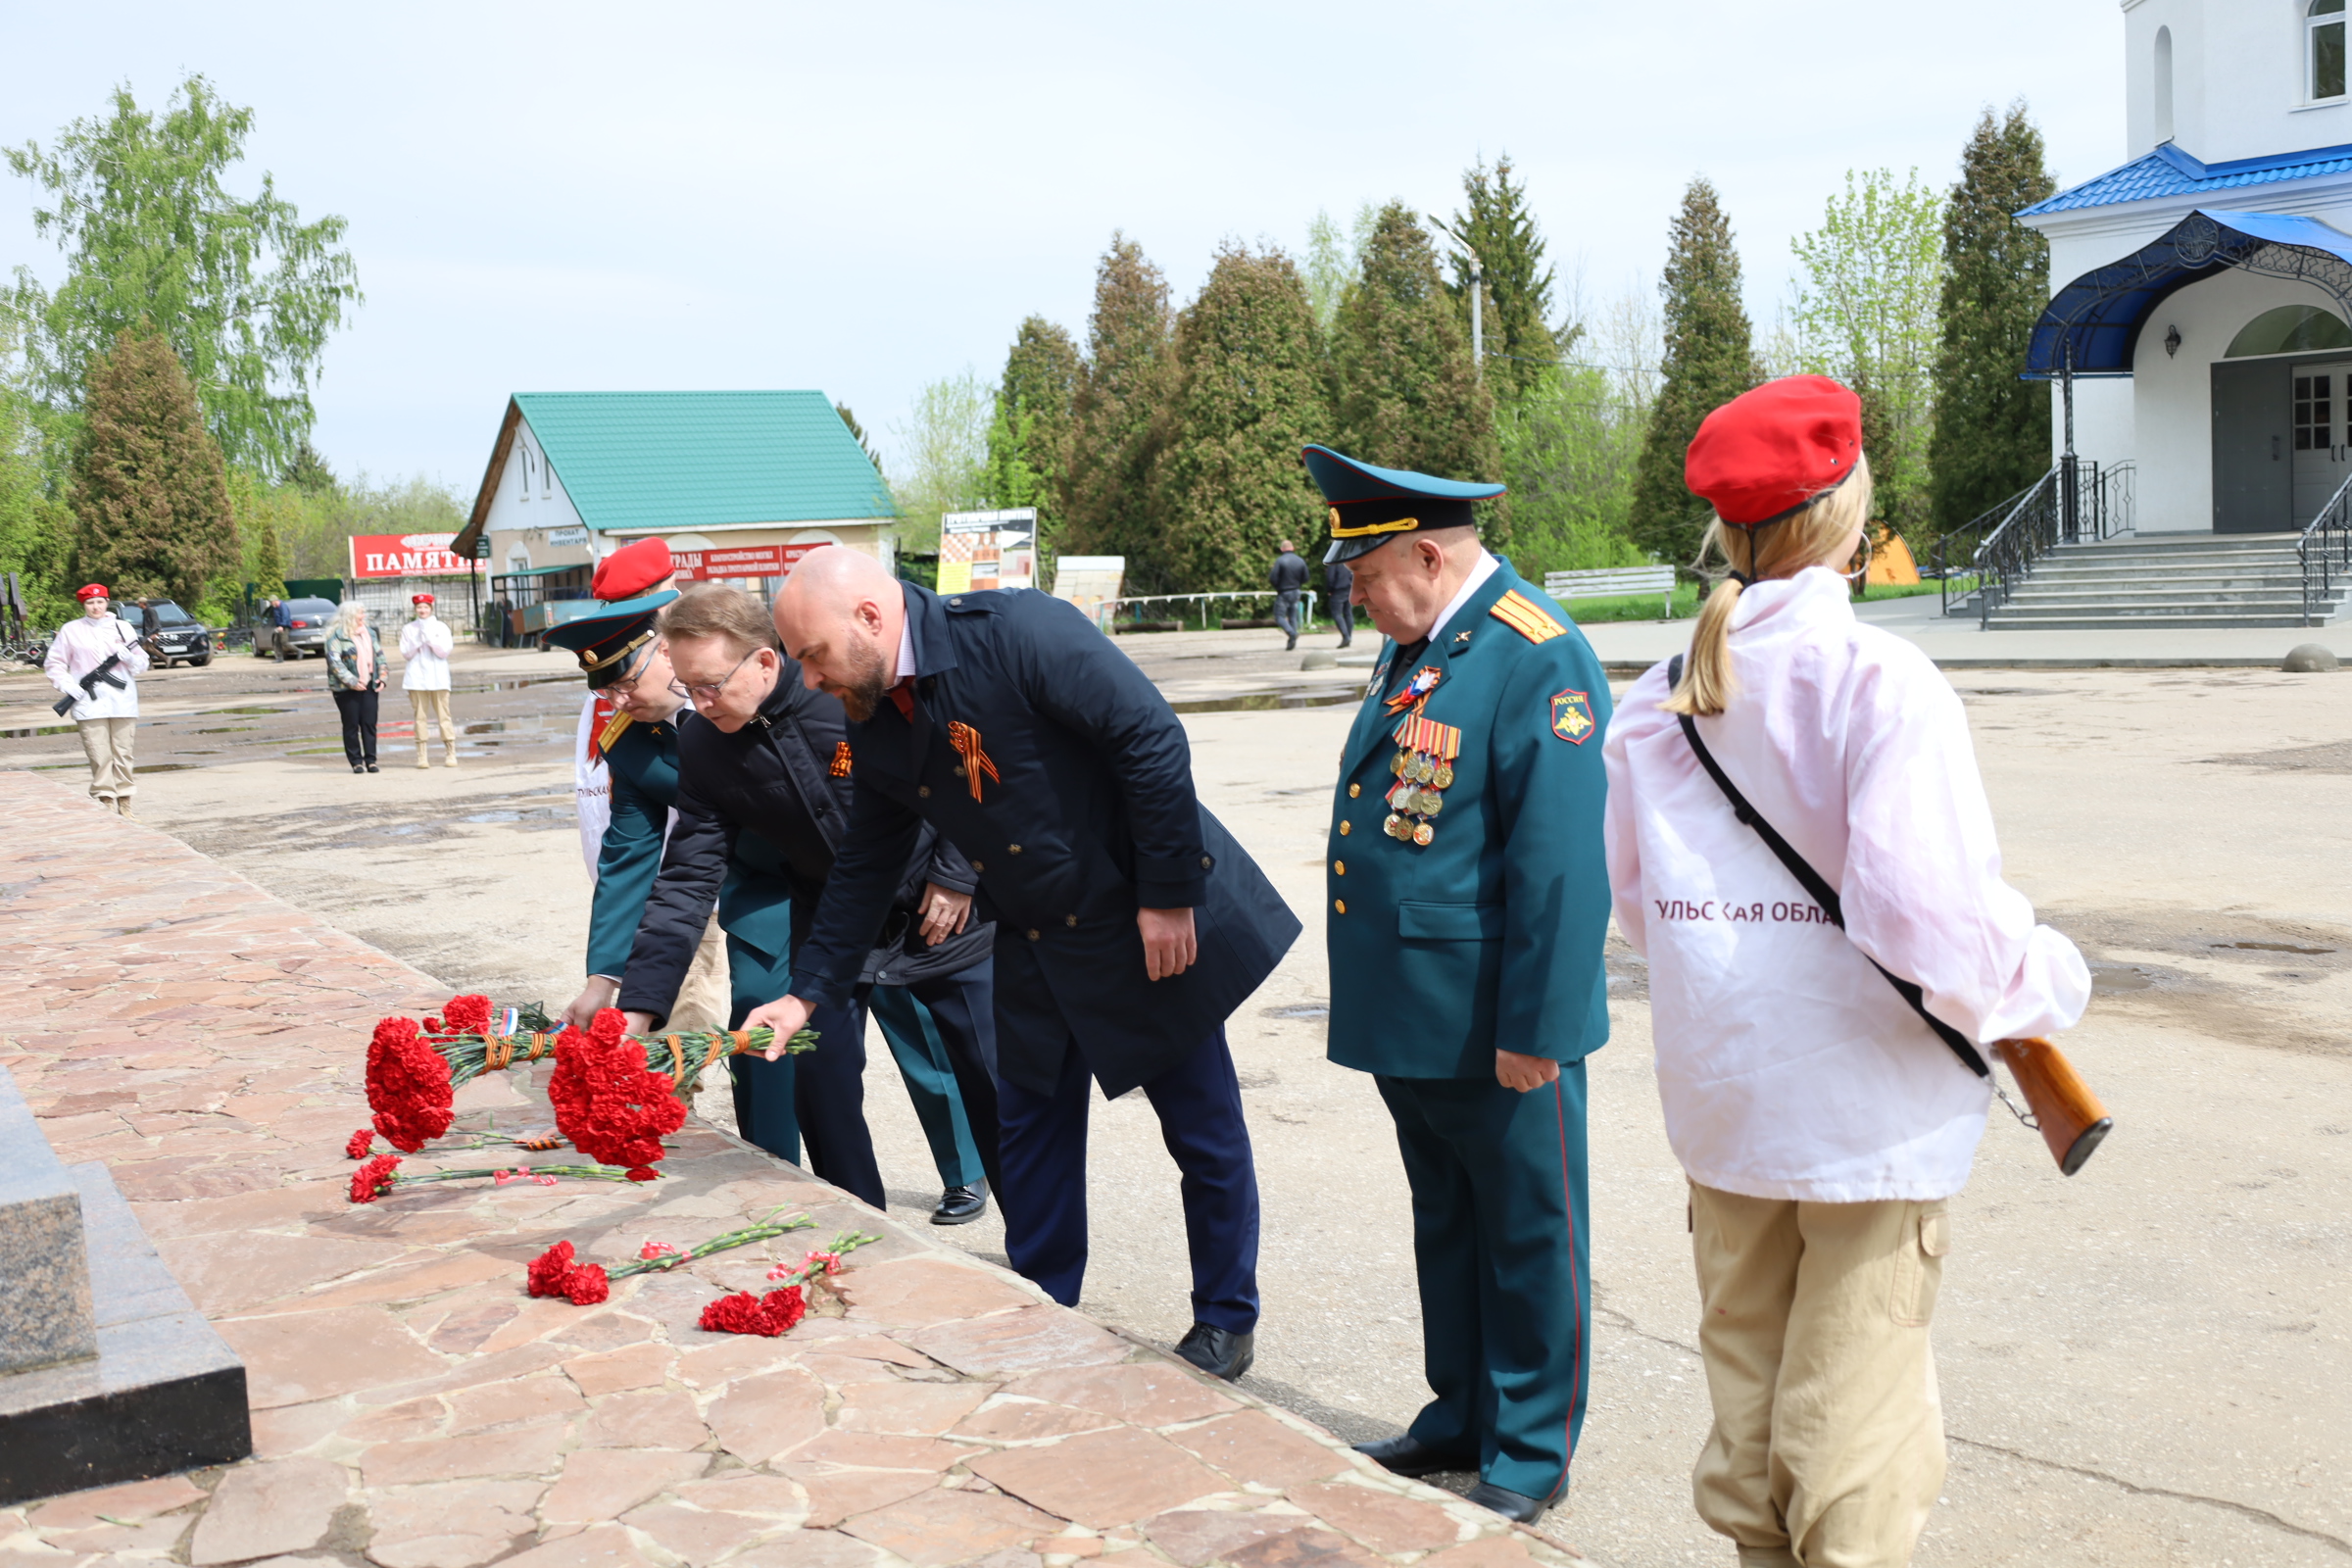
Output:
[793,583,1298,1096]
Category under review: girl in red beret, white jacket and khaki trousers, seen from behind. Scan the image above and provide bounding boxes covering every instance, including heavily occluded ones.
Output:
[1604,376,2091,1568]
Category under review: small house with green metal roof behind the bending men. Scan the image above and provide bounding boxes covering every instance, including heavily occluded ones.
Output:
[449,390,899,602]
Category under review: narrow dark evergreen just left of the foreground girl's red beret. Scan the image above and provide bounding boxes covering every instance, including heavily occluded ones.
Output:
[1625,174,1757,564]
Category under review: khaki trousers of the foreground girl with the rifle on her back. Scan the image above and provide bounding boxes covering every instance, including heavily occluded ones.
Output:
[1691,1183,1952,1568]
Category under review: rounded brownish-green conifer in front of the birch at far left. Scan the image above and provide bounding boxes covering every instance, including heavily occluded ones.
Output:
[73,326,240,607]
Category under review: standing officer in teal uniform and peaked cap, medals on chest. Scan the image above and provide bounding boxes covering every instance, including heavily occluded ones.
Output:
[1305,447,1609,1521]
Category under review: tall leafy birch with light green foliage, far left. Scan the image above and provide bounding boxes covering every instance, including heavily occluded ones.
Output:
[5,75,360,472]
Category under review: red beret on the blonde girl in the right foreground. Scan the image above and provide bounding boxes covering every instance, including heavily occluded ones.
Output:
[1682,376,1863,529]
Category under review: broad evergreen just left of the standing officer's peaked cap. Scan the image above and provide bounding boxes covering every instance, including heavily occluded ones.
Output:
[1143,244,1329,590]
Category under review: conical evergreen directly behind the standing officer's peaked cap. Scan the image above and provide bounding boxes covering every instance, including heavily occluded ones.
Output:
[1331,202,1510,548]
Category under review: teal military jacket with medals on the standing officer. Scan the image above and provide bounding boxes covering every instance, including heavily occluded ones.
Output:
[1324,562,1609,1079]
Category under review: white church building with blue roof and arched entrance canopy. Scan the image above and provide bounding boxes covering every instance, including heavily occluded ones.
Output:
[2018,0,2352,536]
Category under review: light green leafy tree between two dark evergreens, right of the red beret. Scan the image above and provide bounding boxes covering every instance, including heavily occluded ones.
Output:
[1788,170,1942,546]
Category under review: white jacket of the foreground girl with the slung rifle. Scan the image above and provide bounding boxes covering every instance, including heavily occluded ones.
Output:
[1604,566,2091,1203]
